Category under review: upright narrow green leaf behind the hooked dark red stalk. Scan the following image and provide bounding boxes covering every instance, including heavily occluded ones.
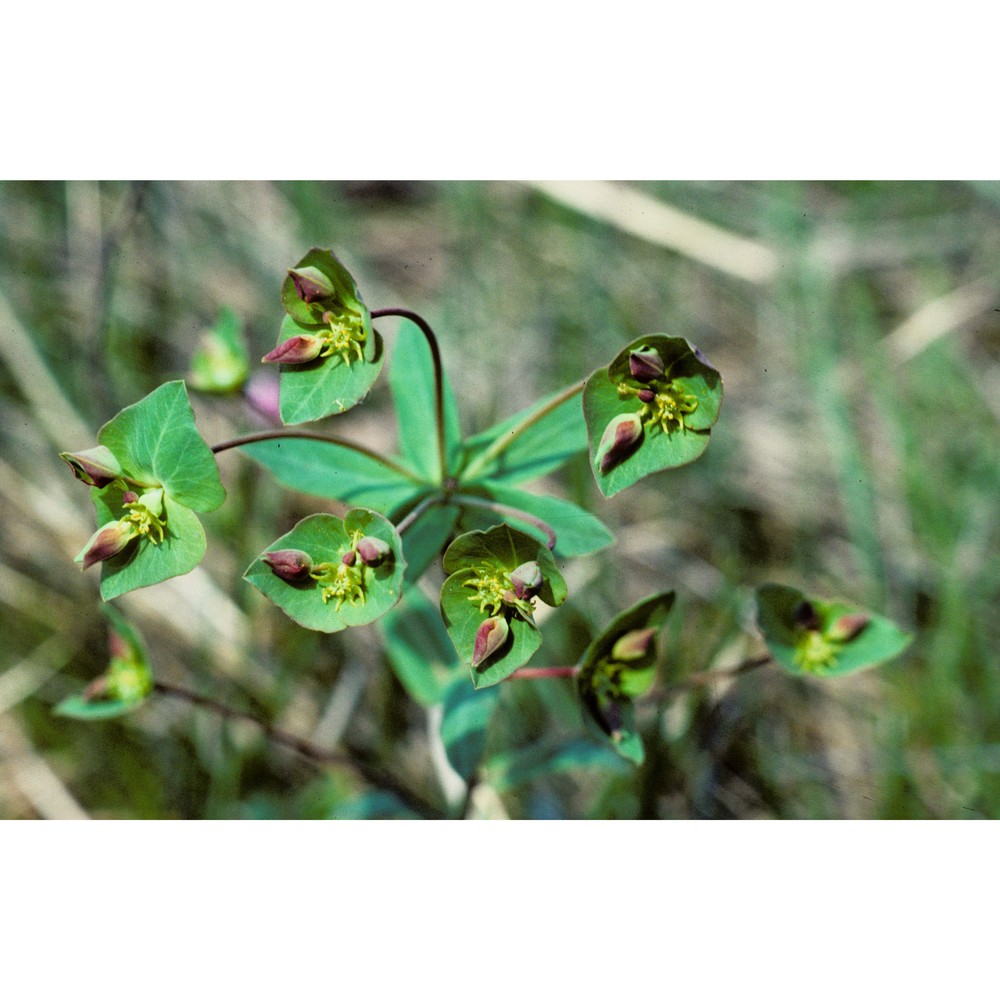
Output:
[389,322,462,482]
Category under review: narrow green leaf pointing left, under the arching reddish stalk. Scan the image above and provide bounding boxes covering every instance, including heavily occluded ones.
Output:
[241,438,425,514]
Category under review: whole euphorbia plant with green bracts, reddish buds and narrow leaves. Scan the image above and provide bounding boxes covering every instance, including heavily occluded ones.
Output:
[54,248,908,804]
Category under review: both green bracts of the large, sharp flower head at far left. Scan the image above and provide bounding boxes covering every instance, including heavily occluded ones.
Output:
[71,381,226,601]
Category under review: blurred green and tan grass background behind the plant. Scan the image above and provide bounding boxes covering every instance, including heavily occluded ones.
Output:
[0,182,1000,819]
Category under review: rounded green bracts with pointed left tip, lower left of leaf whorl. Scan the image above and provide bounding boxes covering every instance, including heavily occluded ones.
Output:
[243,507,406,632]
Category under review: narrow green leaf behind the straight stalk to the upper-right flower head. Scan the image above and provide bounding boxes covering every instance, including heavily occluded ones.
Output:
[465,384,587,485]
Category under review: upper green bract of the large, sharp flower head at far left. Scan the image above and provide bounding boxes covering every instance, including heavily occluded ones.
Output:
[97,381,226,513]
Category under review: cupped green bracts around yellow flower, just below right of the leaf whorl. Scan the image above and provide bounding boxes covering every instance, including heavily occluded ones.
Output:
[441,524,566,688]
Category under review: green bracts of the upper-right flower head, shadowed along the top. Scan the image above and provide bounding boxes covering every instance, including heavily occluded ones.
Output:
[583,334,722,497]
